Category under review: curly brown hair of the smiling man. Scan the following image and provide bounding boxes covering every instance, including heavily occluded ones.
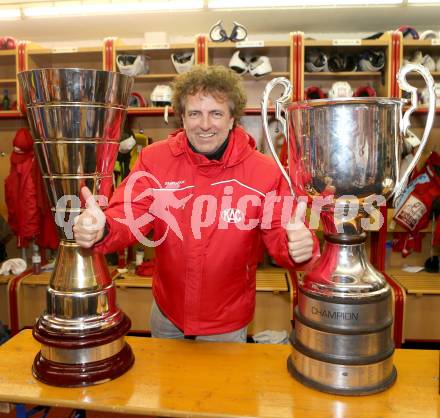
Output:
[172,65,247,124]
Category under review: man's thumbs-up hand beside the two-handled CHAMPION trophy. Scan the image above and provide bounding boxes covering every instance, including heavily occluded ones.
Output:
[286,202,313,263]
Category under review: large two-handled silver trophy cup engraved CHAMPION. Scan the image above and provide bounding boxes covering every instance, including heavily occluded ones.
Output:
[262,64,435,395]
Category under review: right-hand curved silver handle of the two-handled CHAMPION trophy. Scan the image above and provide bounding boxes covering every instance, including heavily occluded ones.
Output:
[393,64,435,203]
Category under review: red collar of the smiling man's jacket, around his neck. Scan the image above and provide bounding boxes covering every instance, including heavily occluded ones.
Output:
[168,125,255,168]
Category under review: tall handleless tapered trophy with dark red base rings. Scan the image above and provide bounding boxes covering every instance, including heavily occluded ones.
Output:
[18,69,134,387]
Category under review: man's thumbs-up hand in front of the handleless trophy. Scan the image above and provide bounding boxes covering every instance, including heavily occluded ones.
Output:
[73,186,105,248]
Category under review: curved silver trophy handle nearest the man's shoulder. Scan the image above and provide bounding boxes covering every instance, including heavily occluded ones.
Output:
[261,77,296,196]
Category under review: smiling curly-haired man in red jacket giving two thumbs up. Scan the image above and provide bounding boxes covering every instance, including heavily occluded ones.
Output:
[74,66,318,342]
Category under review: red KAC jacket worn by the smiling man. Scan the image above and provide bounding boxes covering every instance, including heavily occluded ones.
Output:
[95,127,316,335]
